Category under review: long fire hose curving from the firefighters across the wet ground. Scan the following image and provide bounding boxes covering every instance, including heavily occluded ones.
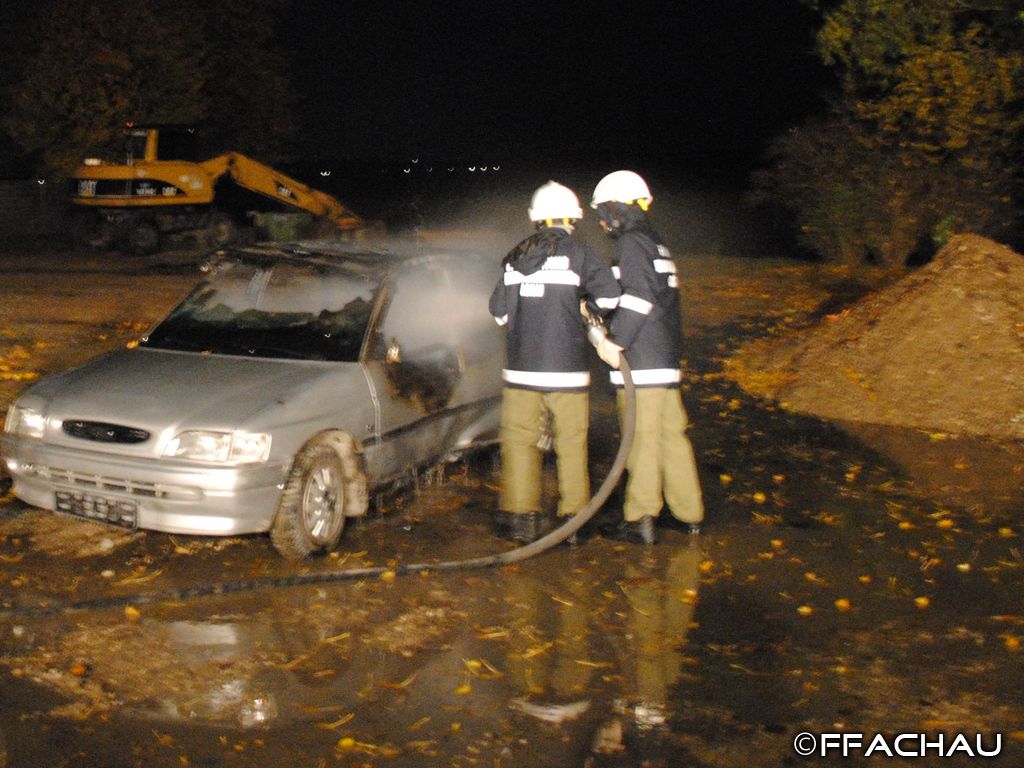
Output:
[6,355,636,616]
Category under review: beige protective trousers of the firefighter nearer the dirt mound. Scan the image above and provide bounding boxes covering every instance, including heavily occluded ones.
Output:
[617,387,703,523]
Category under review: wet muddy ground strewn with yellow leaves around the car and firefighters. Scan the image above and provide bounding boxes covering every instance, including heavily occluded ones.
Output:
[0,249,1024,768]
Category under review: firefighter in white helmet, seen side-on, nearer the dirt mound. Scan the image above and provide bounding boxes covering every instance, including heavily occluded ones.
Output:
[591,171,703,545]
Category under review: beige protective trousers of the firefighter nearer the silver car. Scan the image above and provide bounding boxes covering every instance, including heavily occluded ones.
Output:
[499,387,590,516]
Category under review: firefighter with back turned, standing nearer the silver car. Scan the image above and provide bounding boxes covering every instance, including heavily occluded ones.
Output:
[489,181,620,543]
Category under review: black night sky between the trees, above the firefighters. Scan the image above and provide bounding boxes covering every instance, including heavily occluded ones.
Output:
[282,0,824,173]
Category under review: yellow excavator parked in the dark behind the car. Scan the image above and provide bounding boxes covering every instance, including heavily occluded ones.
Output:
[72,123,366,255]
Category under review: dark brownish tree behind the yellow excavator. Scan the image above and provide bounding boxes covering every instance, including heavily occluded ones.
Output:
[3,0,289,176]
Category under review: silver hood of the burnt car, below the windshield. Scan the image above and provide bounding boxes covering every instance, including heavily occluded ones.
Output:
[31,349,352,432]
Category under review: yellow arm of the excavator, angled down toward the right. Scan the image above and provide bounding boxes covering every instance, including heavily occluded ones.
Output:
[200,152,365,231]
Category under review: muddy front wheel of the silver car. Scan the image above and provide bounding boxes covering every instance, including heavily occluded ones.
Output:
[270,433,369,560]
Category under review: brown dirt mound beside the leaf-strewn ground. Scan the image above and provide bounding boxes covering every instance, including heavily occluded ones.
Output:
[727,234,1024,439]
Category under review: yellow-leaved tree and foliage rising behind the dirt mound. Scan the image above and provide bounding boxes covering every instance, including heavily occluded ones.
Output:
[757,0,1024,268]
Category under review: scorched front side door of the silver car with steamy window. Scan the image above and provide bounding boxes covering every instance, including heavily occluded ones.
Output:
[362,262,463,482]
